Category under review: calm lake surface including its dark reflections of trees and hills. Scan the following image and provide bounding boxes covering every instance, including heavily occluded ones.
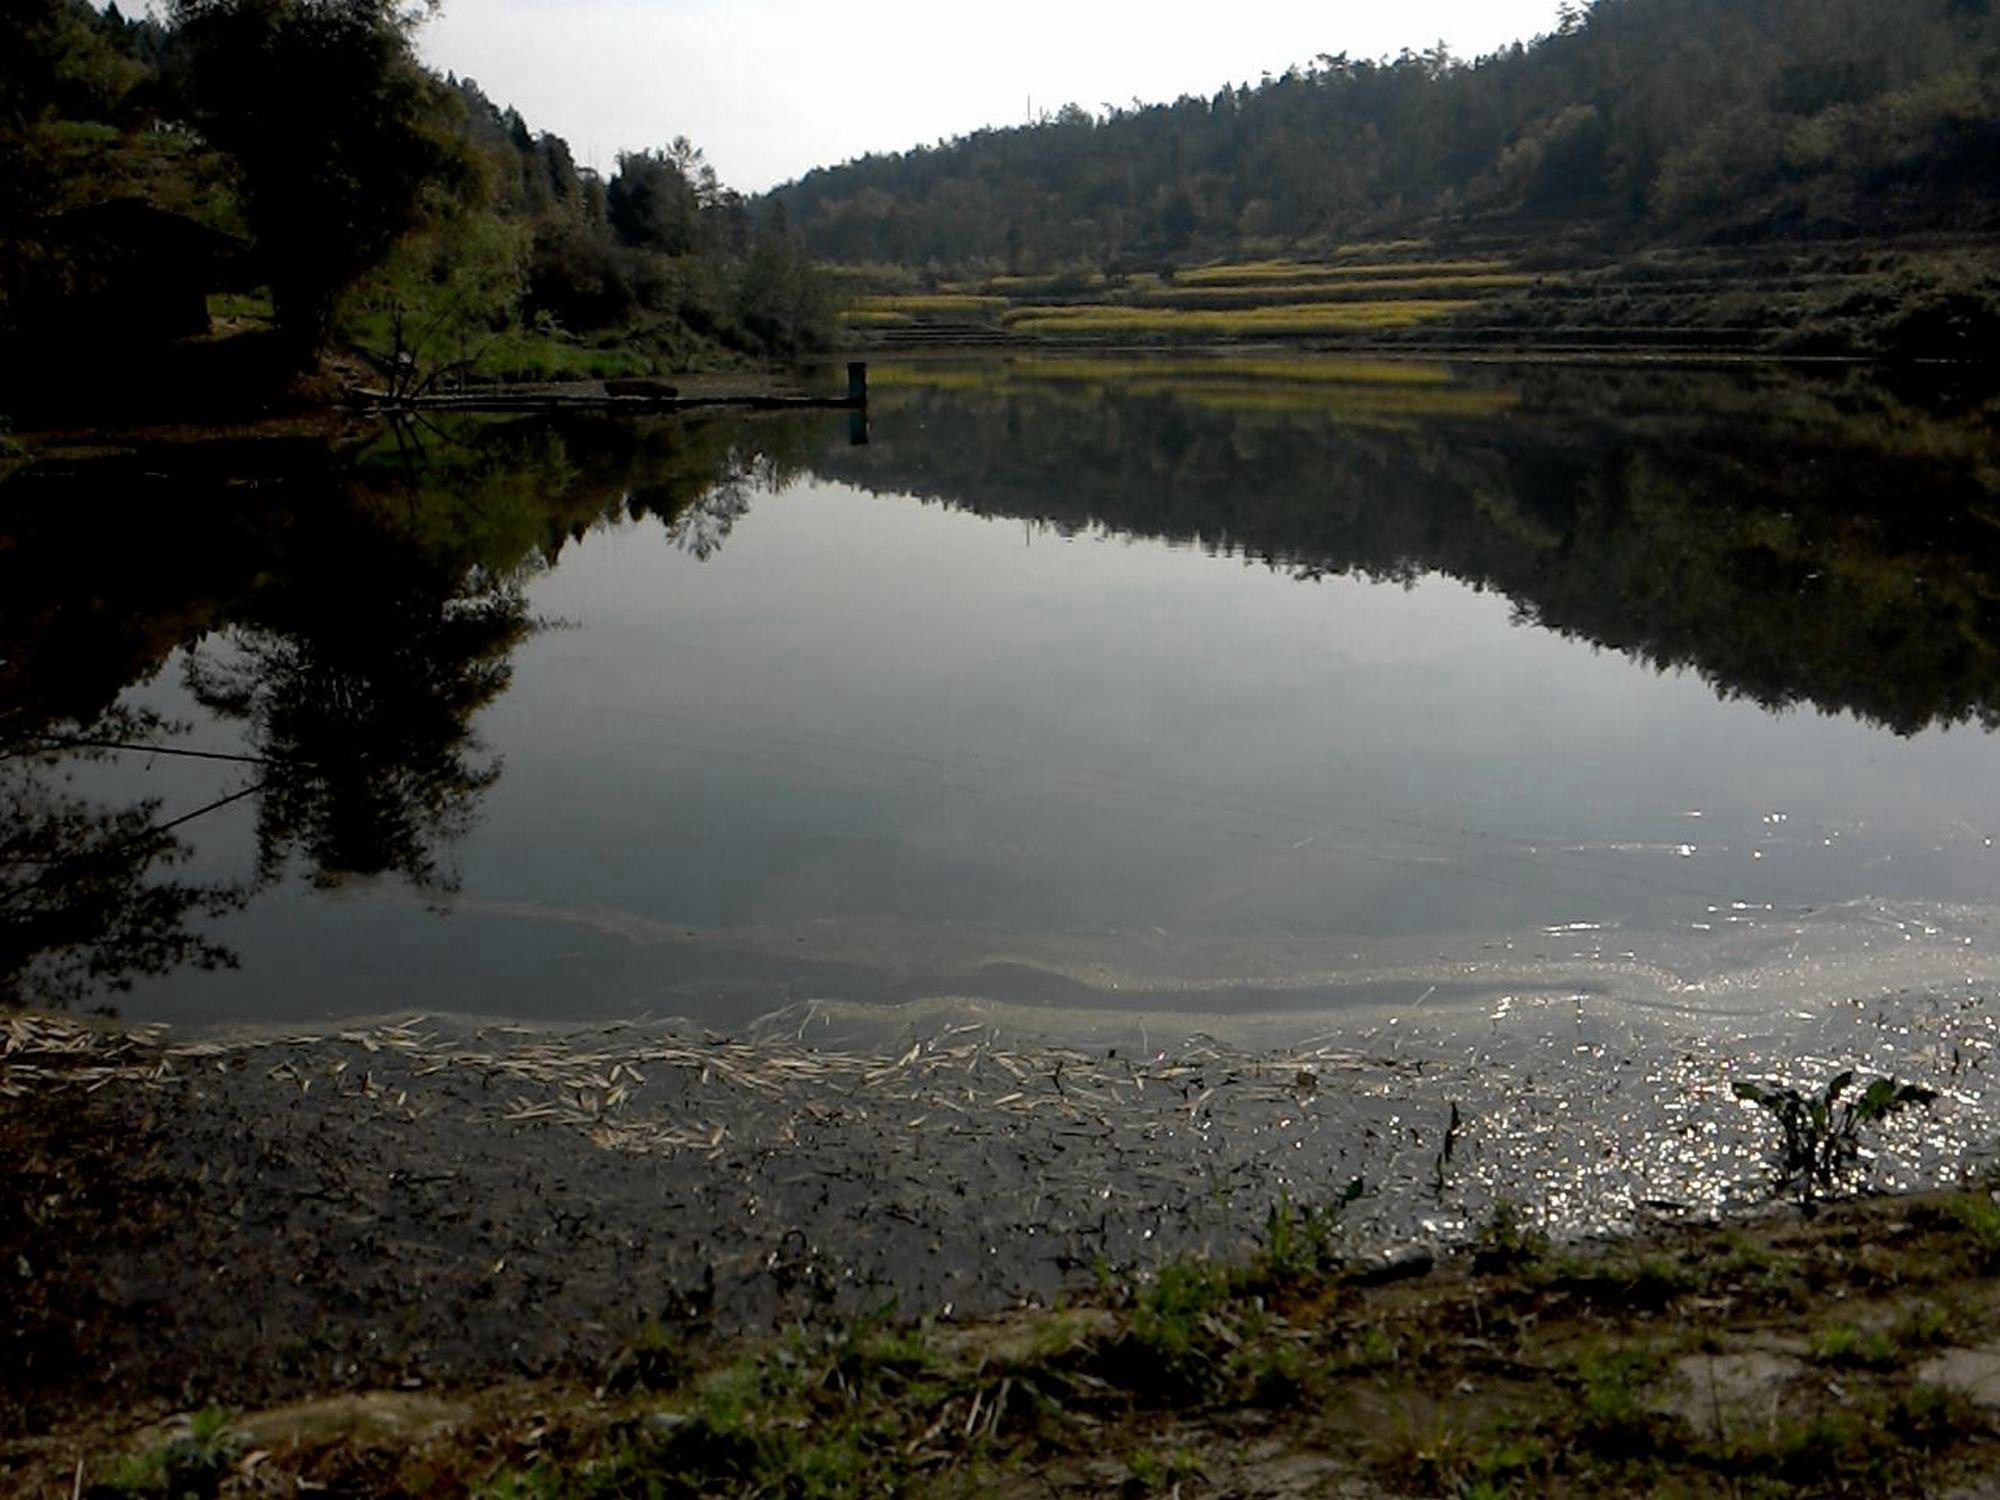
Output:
[11,358,2000,1042]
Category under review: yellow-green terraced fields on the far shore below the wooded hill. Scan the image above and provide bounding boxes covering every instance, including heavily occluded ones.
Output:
[844,238,2000,358]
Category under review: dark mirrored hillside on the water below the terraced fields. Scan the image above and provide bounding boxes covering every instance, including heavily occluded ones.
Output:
[816,362,2000,734]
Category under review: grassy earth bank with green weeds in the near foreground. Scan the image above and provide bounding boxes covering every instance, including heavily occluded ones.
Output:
[84,1194,2000,1498]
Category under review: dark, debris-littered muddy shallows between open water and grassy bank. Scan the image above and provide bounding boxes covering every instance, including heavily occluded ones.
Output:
[0,1016,1974,1444]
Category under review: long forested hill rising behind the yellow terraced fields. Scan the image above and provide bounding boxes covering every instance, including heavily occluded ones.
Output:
[772,0,2000,270]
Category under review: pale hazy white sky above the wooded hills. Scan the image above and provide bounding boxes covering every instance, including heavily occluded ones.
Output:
[422,0,1556,192]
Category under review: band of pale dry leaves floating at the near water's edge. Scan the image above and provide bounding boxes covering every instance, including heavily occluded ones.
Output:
[0,1012,1362,1156]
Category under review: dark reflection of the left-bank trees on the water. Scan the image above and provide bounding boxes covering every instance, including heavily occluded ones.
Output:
[0,422,798,1004]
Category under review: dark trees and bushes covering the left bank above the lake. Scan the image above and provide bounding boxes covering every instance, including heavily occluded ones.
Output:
[0,0,832,390]
